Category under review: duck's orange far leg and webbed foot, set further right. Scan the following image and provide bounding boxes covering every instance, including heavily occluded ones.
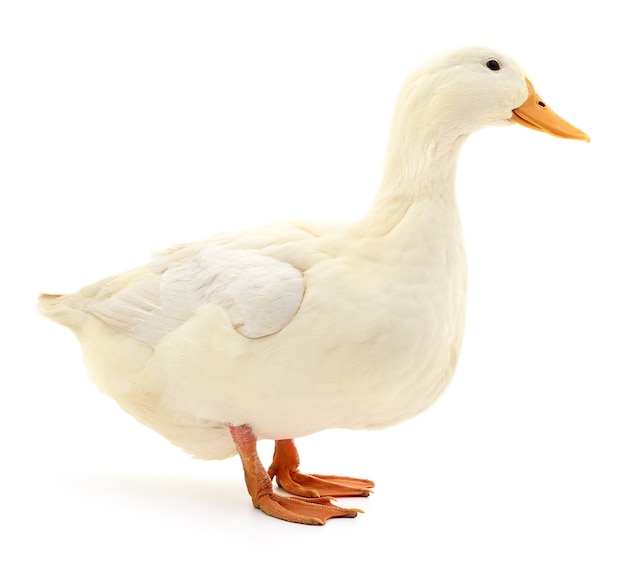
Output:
[268,440,374,498]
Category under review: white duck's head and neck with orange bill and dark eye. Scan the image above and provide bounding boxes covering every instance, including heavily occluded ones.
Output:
[381,48,589,197]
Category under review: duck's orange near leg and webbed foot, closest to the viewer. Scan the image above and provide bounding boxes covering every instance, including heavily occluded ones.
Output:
[230,425,361,525]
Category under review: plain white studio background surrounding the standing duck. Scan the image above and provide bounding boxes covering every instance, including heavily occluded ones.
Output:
[0,0,626,575]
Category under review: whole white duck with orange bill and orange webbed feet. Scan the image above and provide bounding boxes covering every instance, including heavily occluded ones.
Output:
[38,47,589,525]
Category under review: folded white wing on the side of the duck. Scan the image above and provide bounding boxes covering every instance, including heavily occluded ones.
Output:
[85,244,304,345]
